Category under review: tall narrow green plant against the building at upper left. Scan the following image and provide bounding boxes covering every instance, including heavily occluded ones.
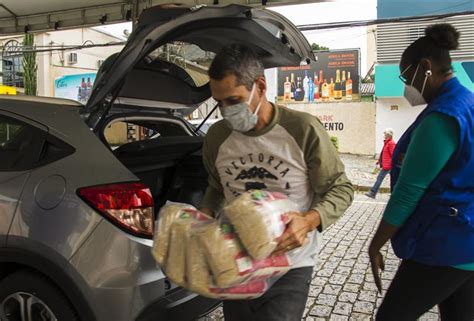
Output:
[23,33,38,96]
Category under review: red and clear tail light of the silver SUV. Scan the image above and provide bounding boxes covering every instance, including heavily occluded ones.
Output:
[77,183,154,238]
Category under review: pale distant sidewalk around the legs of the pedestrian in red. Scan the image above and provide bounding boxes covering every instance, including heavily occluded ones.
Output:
[340,154,390,193]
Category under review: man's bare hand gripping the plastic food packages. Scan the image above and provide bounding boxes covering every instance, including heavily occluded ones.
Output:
[273,210,321,256]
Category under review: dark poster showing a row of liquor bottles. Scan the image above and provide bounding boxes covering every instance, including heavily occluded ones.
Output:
[278,49,360,104]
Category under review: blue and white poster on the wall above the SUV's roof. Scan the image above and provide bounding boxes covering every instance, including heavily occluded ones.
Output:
[54,73,96,104]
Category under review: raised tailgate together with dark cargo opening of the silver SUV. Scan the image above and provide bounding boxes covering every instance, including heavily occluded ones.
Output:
[90,5,314,214]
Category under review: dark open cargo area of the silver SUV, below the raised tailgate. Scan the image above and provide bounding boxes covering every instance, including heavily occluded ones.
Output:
[114,136,207,210]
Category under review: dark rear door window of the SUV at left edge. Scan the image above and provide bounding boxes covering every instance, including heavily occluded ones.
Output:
[0,114,47,171]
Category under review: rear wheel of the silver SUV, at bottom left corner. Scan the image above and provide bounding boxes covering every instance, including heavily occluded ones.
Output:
[0,270,79,321]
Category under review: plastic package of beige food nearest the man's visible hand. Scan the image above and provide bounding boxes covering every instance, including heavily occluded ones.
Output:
[224,190,298,259]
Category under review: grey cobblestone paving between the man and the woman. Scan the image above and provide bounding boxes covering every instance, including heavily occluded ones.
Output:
[202,194,439,321]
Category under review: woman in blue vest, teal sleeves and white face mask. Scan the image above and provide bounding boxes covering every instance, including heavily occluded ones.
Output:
[369,24,474,321]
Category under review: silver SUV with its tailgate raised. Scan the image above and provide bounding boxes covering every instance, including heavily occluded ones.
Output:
[0,5,312,321]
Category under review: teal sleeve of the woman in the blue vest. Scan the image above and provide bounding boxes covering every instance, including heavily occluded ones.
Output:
[383,113,459,226]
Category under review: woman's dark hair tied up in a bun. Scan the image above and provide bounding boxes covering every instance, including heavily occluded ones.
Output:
[402,23,460,72]
